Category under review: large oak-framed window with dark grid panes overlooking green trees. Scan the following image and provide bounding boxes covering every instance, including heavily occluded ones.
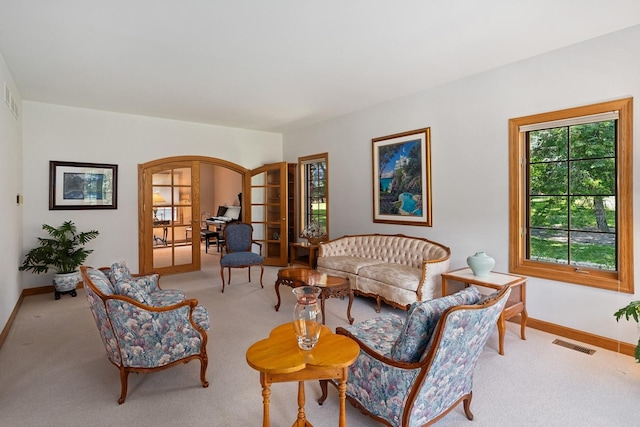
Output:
[509,98,633,293]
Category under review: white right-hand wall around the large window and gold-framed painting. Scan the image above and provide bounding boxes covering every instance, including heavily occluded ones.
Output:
[284,26,640,343]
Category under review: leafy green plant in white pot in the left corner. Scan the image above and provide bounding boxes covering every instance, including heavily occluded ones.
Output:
[19,221,99,299]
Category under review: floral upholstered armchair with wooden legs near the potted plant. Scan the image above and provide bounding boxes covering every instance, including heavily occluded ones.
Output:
[80,263,210,403]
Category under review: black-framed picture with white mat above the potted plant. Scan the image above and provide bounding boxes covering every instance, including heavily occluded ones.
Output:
[49,160,118,210]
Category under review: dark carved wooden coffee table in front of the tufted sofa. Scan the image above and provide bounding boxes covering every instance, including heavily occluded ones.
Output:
[275,268,353,325]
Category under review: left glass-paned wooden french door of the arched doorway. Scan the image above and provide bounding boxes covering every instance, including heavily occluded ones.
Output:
[139,161,200,274]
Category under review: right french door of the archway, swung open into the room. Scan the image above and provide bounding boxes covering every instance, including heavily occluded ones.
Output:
[245,162,288,266]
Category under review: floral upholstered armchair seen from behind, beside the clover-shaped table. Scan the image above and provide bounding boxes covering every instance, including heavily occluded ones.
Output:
[319,287,511,427]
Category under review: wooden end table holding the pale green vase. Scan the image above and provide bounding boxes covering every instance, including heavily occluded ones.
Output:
[442,267,528,355]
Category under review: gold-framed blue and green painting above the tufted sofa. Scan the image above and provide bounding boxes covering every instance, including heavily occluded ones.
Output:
[371,127,432,227]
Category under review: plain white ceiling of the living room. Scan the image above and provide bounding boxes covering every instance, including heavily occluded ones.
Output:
[0,0,640,132]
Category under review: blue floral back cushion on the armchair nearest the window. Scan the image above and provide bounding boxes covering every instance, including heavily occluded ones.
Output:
[391,286,481,363]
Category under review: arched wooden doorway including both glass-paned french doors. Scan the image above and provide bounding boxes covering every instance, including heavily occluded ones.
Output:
[138,156,288,274]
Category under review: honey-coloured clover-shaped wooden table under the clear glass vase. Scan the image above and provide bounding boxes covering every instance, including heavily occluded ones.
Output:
[247,322,360,427]
